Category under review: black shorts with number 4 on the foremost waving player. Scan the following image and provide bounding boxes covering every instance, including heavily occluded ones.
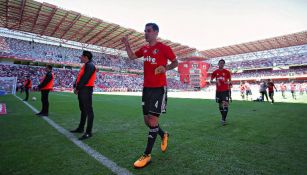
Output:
[142,87,167,117]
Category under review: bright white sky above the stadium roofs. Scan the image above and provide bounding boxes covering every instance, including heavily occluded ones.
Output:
[38,0,307,50]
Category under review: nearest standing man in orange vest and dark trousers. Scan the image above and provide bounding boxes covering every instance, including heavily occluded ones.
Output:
[70,51,96,140]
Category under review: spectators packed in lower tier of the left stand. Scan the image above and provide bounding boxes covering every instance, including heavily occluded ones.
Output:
[0,64,187,91]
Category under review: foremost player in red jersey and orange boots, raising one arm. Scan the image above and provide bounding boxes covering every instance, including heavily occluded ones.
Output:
[122,23,178,168]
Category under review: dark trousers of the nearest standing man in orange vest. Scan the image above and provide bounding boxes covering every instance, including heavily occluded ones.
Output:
[78,87,94,133]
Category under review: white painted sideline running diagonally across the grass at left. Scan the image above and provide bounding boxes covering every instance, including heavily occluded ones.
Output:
[14,95,132,175]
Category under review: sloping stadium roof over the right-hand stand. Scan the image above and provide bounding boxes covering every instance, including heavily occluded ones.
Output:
[201,31,307,59]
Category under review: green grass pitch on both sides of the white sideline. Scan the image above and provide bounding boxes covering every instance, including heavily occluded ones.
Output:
[0,93,307,174]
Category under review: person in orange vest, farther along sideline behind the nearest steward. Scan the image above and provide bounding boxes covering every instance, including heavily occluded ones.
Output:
[36,65,54,116]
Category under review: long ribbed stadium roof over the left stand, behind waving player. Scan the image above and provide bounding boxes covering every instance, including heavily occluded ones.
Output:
[0,0,196,57]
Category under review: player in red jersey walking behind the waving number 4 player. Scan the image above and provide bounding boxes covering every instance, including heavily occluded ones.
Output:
[210,59,231,125]
